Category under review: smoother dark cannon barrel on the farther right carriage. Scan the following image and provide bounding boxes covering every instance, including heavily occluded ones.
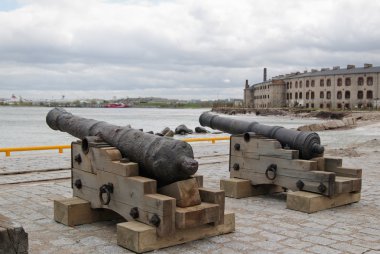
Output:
[199,112,324,160]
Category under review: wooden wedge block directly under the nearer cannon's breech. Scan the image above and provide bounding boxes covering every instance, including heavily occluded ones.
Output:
[158,178,201,207]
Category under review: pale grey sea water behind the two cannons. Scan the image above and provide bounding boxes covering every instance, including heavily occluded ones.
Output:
[0,107,380,148]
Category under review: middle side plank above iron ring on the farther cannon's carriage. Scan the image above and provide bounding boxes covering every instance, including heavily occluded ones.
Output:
[230,156,317,172]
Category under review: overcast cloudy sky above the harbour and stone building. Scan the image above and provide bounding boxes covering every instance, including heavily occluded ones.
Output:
[0,0,380,99]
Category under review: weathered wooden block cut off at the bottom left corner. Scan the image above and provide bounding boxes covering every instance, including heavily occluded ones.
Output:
[0,214,28,254]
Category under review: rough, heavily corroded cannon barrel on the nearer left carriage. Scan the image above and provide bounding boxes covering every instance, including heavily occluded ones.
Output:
[46,108,198,186]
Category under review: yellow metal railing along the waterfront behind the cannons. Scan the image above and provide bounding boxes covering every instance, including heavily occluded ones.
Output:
[0,137,230,157]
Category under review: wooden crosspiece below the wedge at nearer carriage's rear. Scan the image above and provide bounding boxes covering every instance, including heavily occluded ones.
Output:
[175,202,220,229]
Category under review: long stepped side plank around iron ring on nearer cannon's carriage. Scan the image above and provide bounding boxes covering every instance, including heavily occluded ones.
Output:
[73,169,175,235]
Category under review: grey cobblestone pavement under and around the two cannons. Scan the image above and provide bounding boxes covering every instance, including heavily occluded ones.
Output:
[0,142,380,254]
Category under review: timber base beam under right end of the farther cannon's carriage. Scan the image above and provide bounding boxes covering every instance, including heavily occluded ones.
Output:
[286,191,360,213]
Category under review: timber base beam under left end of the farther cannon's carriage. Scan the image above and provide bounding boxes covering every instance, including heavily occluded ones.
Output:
[220,178,283,198]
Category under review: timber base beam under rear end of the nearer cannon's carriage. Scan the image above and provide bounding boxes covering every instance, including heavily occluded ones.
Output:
[117,213,235,253]
